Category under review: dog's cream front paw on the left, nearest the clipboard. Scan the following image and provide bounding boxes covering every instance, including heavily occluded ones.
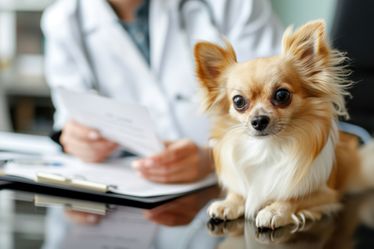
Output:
[208,192,244,220]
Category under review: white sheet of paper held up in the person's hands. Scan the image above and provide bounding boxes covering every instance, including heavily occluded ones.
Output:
[57,88,163,156]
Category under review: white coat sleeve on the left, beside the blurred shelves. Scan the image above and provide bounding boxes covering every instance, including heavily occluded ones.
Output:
[41,1,89,130]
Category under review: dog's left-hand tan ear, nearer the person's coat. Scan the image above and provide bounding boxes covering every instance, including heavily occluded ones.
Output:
[195,41,236,109]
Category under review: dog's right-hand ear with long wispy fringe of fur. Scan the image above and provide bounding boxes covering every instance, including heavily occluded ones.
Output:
[282,20,352,117]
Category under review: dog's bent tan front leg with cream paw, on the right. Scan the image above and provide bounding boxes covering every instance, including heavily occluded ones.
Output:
[256,189,341,229]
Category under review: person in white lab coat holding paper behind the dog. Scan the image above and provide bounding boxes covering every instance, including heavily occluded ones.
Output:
[42,0,283,182]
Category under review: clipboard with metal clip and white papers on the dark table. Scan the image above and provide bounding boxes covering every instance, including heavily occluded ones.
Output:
[0,155,217,203]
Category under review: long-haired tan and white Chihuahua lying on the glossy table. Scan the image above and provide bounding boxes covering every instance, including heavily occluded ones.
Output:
[194,20,374,229]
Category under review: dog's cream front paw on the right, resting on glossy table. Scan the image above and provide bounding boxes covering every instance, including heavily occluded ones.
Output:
[256,205,293,230]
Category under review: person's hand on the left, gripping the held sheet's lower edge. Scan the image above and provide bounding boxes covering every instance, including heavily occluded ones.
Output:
[60,120,118,163]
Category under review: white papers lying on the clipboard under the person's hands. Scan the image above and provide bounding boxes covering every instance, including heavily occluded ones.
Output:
[3,155,217,197]
